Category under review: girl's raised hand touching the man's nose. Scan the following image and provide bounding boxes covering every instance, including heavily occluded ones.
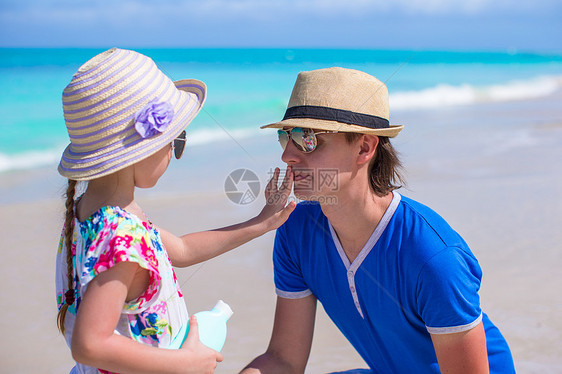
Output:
[257,166,297,231]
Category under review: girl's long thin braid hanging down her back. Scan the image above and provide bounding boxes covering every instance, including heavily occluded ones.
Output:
[57,179,77,335]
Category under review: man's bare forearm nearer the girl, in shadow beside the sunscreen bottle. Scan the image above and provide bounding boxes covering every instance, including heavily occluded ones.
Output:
[241,295,316,374]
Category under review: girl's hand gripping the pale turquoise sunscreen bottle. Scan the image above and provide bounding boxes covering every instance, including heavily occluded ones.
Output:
[181,316,223,373]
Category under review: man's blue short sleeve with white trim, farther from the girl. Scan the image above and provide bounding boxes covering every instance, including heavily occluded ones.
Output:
[417,247,482,334]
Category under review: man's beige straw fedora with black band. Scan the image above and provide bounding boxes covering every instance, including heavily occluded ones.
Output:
[261,67,404,138]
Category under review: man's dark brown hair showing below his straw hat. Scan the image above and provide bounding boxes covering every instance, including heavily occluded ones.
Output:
[345,132,405,196]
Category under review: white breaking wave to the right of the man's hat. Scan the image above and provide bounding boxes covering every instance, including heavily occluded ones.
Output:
[390,76,562,110]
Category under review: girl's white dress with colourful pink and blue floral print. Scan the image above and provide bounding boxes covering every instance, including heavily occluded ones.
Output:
[55,206,188,374]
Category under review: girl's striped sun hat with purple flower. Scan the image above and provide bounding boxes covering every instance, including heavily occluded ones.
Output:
[58,48,206,180]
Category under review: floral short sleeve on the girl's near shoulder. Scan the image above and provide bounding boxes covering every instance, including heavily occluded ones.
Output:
[80,217,161,313]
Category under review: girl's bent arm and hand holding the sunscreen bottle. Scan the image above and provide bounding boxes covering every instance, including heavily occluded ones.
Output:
[71,262,222,374]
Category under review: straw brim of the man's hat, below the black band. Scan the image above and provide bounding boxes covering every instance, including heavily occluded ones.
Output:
[260,118,404,138]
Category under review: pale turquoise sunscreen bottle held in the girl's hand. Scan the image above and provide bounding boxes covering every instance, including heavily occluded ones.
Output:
[169,300,233,352]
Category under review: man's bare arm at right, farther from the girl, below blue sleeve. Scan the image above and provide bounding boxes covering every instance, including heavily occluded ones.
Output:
[431,322,489,374]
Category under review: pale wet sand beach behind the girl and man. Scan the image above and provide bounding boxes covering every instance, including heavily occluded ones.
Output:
[0,93,562,374]
